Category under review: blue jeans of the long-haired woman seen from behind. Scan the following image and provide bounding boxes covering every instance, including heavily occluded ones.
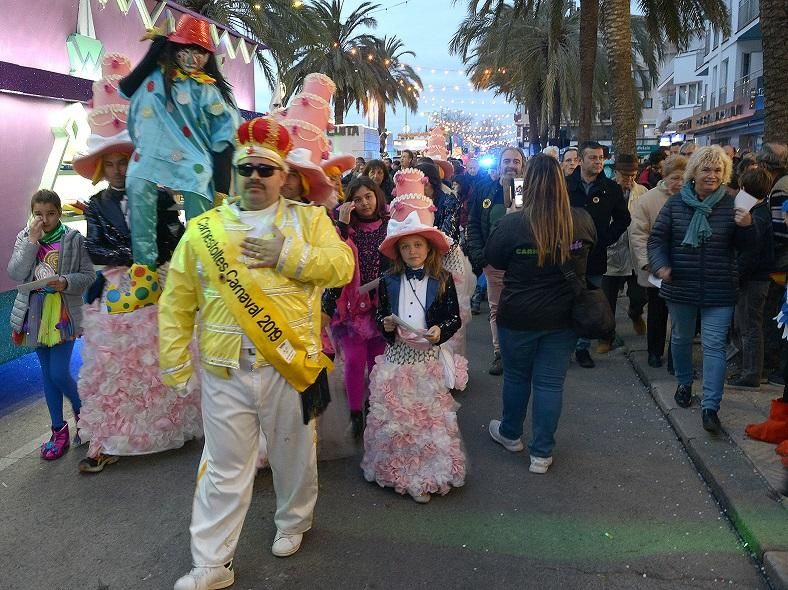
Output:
[498,326,577,457]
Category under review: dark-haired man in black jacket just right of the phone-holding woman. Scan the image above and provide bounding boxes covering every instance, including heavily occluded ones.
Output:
[566,141,631,369]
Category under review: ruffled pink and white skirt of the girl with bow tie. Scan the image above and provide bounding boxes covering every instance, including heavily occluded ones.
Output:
[361,342,465,496]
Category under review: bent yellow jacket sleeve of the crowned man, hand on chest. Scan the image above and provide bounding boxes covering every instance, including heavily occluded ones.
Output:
[276,207,355,288]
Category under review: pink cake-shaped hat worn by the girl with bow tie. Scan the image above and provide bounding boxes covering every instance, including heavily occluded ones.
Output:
[378,168,452,260]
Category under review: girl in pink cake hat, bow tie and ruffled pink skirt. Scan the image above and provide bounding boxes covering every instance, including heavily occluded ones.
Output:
[361,169,467,503]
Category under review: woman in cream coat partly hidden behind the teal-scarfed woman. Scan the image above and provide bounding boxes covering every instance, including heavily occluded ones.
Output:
[629,154,687,367]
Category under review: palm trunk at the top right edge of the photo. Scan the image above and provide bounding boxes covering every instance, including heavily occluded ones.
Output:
[760,0,788,143]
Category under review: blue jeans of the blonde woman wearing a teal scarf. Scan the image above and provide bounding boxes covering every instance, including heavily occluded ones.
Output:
[668,301,733,411]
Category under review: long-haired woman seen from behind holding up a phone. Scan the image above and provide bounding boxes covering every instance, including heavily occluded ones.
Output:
[484,155,596,473]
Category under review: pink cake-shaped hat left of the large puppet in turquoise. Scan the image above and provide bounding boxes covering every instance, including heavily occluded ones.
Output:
[72,53,134,184]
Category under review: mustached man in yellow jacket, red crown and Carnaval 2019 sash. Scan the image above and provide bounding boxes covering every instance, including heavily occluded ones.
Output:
[159,117,354,590]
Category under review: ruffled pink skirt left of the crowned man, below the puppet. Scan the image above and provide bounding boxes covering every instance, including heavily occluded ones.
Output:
[78,304,202,457]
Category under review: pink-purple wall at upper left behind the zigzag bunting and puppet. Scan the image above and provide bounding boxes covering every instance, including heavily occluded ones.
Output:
[0,0,254,291]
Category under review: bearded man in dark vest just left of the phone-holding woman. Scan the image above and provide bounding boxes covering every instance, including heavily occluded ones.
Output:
[468,147,525,375]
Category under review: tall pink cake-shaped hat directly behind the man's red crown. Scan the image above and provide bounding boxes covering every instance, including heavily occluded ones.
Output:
[272,74,344,205]
